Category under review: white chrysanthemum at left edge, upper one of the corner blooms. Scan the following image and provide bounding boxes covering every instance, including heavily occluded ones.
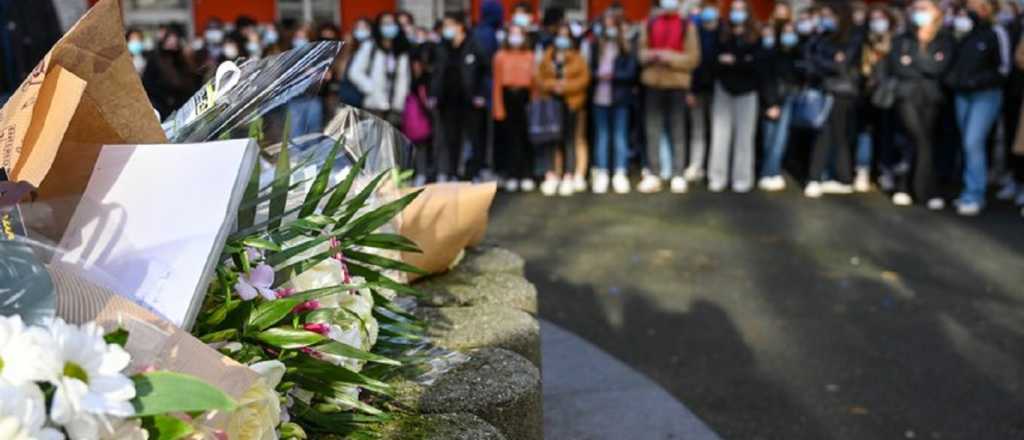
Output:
[0,315,56,385]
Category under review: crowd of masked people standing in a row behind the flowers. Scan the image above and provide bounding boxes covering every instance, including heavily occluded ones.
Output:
[128,0,1024,216]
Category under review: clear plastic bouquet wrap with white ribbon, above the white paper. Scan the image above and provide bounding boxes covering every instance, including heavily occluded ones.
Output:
[163,42,341,143]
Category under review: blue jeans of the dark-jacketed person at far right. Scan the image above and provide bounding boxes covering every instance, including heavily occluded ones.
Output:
[955,89,1002,205]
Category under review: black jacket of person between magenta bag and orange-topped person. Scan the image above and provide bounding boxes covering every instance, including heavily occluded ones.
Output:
[430,36,490,103]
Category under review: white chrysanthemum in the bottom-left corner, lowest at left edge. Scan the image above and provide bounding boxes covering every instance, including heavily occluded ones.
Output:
[0,380,63,440]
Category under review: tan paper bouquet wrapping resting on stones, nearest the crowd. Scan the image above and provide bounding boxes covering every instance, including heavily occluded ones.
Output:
[401,183,498,280]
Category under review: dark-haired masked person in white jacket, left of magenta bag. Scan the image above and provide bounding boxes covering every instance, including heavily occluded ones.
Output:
[348,12,412,127]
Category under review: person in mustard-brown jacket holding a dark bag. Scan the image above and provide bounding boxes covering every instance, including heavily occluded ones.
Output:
[537,25,590,195]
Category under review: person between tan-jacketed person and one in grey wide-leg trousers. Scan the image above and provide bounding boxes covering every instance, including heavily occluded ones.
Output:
[683,0,721,182]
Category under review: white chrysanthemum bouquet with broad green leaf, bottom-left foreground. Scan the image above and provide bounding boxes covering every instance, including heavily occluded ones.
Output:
[0,315,238,440]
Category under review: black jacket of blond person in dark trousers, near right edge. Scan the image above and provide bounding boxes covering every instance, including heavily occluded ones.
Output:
[883,31,956,101]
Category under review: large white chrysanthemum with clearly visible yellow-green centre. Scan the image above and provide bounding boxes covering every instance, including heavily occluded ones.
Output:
[49,318,135,440]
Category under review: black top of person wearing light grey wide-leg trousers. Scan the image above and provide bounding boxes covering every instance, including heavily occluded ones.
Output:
[714,35,765,95]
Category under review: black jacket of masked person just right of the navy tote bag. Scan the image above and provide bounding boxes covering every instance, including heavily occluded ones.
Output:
[805,33,862,97]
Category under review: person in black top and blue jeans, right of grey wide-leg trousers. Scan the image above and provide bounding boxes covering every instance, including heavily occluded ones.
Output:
[758,21,802,191]
